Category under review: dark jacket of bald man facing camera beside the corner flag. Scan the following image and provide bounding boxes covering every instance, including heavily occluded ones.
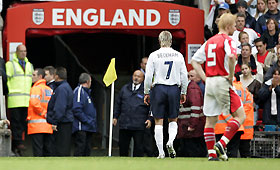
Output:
[114,83,149,130]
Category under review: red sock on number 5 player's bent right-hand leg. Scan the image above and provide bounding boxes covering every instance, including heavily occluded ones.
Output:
[220,119,240,148]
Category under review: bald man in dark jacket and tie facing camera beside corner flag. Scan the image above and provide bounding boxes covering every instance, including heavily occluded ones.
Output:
[113,70,151,157]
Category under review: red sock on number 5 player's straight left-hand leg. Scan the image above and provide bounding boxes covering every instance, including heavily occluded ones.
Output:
[204,128,217,158]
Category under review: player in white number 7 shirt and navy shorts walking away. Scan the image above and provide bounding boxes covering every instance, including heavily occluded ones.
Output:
[144,31,188,159]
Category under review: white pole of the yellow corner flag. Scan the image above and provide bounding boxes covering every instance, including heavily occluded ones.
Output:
[108,82,115,156]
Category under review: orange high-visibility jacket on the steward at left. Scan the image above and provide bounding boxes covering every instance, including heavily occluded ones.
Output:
[27,79,53,135]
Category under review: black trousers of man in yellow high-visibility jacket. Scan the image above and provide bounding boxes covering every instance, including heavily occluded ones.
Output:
[10,107,27,150]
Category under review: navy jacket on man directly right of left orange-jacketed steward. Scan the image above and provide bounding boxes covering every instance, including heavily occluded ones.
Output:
[47,81,74,125]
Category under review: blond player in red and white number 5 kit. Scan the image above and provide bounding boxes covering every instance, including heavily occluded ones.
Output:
[191,14,245,161]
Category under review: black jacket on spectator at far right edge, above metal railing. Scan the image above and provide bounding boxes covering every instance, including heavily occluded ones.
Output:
[258,80,280,125]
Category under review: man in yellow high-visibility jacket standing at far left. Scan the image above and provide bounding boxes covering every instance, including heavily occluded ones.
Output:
[6,44,33,155]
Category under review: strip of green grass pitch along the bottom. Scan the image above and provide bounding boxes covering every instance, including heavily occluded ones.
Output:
[0,157,280,170]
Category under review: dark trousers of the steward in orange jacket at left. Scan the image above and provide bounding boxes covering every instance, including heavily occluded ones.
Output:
[30,133,54,156]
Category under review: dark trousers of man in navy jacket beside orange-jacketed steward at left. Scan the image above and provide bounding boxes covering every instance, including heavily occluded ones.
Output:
[54,122,72,156]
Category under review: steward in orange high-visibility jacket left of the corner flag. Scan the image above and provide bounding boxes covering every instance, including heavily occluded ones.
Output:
[27,68,53,156]
